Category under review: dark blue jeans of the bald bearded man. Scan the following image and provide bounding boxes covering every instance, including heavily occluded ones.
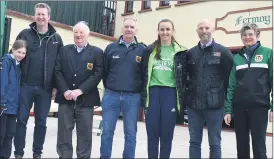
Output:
[187,107,224,158]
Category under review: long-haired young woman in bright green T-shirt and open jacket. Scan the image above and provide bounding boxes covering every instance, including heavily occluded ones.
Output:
[141,19,186,158]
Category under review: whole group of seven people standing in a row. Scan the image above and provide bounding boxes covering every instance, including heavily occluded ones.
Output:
[0,3,273,159]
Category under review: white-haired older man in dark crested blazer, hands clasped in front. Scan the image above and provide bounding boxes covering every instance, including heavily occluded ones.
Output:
[55,22,103,158]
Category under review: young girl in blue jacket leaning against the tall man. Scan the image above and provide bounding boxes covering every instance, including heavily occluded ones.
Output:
[0,40,27,158]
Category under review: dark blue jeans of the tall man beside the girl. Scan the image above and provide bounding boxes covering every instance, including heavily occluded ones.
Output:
[14,84,51,156]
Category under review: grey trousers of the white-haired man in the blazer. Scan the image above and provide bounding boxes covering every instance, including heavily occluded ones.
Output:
[57,104,93,158]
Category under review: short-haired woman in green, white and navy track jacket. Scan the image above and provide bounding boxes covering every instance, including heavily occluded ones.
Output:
[224,24,273,158]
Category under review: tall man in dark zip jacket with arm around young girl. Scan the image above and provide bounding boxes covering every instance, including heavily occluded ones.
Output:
[14,3,63,158]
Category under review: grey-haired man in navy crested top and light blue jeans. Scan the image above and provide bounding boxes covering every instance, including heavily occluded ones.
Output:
[100,18,145,158]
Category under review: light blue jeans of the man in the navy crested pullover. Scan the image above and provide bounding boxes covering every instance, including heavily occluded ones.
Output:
[100,89,141,158]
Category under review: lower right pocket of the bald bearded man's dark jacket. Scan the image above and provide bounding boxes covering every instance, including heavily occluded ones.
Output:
[207,90,225,108]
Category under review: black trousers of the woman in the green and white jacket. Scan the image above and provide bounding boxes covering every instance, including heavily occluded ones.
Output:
[233,107,268,159]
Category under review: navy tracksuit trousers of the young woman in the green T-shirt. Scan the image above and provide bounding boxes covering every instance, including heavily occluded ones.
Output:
[145,86,177,158]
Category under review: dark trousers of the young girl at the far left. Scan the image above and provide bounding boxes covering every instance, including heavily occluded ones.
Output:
[0,114,16,158]
